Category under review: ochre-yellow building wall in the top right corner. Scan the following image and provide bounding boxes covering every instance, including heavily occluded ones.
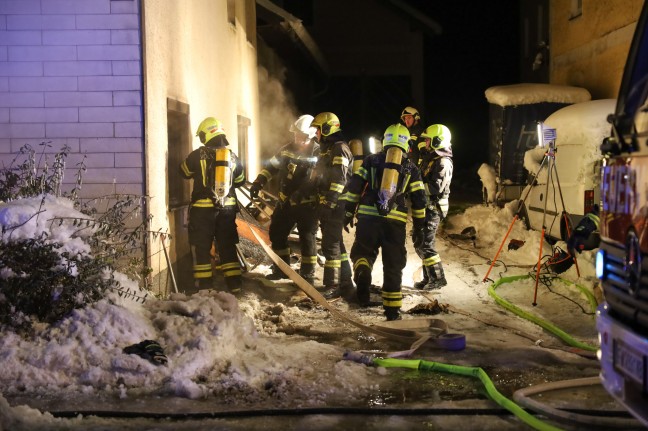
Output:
[550,0,644,99]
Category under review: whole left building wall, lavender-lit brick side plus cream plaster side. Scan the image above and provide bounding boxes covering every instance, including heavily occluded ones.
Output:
[0,0,260,292]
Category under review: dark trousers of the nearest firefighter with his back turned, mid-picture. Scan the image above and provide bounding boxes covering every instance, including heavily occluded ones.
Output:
[351,216,407,309]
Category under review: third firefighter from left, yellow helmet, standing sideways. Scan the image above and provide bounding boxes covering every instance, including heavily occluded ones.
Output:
[311,112,354,299]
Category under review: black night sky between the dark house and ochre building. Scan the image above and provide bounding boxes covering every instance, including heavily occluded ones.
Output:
[416,0,520,175]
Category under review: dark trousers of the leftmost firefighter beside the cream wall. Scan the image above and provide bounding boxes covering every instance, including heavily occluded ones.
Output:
[189,207,243,291]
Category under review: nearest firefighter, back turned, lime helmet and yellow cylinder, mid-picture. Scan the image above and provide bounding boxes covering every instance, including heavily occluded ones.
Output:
[345,124,426,320]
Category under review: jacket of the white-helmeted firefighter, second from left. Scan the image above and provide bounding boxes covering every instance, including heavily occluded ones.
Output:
[254,141,320,203]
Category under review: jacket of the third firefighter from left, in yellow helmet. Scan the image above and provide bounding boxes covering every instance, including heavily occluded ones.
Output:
[311,132,353,207]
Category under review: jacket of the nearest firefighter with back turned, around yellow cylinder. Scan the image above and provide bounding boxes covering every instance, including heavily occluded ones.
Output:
[345,150,427,226]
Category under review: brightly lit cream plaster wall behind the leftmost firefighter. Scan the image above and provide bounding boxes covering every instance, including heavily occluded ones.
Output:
[143,0,259,290]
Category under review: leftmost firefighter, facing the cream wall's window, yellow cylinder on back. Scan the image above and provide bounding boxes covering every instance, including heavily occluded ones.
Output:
[180,117,245,293]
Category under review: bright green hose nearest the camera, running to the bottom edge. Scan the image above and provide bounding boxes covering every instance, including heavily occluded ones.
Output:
[344,352,561,431]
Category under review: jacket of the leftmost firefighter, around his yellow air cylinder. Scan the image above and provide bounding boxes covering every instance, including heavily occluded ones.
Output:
[180,142,245,209]
